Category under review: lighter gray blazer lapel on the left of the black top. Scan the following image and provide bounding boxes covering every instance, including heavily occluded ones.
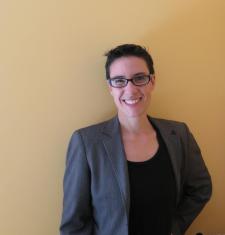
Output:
[102,116,130,216]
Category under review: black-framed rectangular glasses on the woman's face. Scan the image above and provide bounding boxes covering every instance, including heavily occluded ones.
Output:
[108,74,153,88]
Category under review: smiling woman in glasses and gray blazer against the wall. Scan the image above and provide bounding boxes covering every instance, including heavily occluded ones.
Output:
[60,44,211,235]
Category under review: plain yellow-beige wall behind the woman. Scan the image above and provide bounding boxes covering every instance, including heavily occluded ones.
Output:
[0,0,225,235]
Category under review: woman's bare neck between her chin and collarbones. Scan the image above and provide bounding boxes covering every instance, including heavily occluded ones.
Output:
[118,114,153,135]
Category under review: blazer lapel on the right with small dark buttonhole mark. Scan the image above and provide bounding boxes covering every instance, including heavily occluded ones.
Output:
[149,118,181,203]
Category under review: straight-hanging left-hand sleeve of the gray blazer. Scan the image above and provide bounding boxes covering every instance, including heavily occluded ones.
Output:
[60,131,93,235]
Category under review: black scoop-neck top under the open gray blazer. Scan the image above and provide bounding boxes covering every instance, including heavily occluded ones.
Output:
[128,129,176,235]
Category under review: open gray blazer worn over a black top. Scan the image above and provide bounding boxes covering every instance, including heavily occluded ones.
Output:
[60,116,212,235]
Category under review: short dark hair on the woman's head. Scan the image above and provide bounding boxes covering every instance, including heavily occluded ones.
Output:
[105,44,155,79]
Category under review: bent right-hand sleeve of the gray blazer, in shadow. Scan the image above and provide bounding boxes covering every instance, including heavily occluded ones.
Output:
[172,125,212,235]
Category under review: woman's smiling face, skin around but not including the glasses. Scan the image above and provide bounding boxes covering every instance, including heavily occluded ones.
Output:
[109,56,155,118]
